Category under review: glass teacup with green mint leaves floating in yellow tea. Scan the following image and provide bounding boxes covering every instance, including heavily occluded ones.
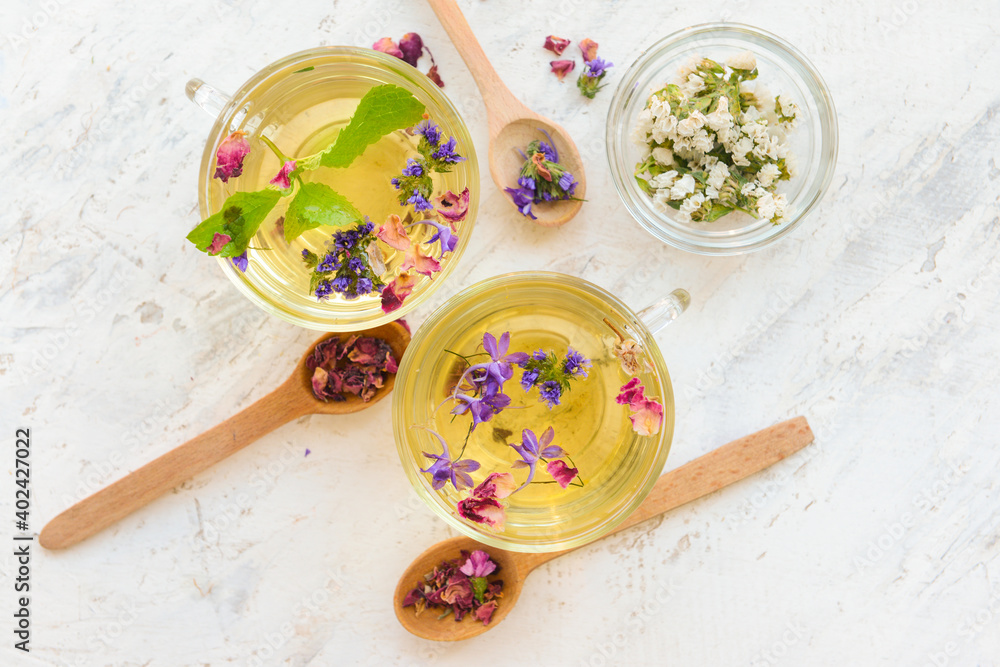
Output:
[194,46,479,331]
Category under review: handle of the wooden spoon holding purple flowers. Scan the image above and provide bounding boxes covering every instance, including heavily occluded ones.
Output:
[427,0,534,134]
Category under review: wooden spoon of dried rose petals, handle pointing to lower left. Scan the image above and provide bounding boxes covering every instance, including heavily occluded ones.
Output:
[38,322,410,549]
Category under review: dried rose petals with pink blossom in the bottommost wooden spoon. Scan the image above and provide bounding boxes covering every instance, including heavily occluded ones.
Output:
[402,550,503,625]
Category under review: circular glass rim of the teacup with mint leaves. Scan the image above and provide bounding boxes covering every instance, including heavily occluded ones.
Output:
[198,45,479,331]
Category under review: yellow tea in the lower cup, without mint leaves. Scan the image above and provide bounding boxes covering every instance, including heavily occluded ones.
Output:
[422,296,673,510]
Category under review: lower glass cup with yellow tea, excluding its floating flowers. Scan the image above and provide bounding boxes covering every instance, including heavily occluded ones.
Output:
[392,272,688,552]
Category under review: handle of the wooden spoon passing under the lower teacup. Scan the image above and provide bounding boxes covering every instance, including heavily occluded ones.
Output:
[523,417,813,570]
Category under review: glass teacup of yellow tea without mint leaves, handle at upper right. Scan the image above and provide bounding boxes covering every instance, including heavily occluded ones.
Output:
[393,272,689,552]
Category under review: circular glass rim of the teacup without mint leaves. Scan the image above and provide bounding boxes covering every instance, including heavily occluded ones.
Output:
[392,271,675,553]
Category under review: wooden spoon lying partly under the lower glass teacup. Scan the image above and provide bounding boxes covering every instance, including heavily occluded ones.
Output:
[393,417,813,641]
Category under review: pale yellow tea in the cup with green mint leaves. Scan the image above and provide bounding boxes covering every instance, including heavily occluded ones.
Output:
[210,72,465,310]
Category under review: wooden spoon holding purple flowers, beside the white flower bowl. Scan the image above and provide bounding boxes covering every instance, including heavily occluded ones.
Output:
[428,0,587,227]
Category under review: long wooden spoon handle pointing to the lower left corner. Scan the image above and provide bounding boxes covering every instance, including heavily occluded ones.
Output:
[38,381,309,549]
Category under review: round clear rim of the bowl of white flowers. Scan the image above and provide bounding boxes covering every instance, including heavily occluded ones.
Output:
[605,22,840,255]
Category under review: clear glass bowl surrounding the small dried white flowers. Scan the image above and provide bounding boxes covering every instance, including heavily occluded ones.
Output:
[607,23,837,255]
